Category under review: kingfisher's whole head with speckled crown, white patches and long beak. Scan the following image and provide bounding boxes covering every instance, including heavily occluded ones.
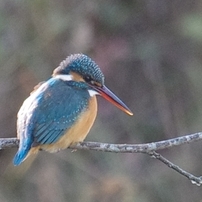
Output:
[53,54,133,115]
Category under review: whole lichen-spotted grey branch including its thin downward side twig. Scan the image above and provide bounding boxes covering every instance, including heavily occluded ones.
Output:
[0,132,202,186]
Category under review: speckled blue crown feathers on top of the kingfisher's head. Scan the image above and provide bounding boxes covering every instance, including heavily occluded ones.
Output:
[53,54,104,85]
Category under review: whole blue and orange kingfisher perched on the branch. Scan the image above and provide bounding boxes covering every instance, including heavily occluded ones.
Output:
[13,54,133,166]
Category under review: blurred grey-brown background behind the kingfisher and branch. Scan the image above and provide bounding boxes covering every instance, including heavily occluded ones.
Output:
[0,0,202,202]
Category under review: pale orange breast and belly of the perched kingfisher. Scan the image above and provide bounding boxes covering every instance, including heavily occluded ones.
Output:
[30,96,97,153]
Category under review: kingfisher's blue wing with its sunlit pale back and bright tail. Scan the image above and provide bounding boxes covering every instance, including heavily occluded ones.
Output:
[14,78,90,165]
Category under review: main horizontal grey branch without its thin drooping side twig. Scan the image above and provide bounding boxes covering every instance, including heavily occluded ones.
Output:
[0,132,202,153]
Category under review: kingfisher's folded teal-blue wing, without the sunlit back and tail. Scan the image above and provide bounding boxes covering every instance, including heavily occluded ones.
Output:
[31,79,90,144]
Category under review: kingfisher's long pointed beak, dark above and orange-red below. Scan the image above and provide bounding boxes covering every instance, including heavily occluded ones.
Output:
[93,86,133,116]
